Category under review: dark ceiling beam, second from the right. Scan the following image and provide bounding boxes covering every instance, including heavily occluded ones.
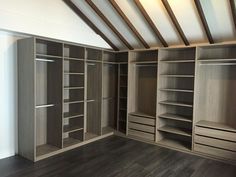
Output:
[194,0,214,44]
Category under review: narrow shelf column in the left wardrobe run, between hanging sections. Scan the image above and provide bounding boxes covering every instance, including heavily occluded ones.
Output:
[63,44,85,147]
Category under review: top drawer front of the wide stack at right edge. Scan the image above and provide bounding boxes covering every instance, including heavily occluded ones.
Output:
[195,126,236,142]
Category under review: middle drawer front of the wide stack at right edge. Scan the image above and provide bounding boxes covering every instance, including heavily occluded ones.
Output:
[194,135,236,151]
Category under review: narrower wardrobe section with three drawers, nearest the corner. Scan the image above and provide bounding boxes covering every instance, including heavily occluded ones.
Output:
[128,50,158,141]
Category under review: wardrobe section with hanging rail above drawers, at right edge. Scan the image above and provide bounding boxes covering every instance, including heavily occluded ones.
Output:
[194,45,236,161]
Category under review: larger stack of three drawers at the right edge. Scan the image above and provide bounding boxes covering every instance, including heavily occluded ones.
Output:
[194,121,236,160]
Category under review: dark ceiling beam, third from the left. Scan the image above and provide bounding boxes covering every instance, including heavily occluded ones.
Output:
[109,0,150,49]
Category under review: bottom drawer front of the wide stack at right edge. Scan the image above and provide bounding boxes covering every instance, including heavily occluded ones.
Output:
[194,144,236,160]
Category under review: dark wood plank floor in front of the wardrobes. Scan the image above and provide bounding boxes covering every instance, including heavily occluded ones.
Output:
[0,136,236,177]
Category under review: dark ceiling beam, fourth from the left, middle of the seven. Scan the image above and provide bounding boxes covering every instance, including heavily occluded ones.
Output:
[134,0,168,47]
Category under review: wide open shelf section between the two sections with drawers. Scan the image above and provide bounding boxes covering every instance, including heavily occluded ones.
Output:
[156,47,196,150]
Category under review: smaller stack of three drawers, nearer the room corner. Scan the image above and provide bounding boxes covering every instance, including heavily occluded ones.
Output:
[128,114,156,141]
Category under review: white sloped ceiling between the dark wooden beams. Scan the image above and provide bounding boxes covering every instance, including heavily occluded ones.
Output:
[72,0,236,50]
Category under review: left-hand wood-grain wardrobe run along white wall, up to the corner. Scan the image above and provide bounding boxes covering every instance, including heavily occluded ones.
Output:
[18,37,128,161]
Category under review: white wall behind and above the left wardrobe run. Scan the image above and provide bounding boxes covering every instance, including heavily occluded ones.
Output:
[0,0,110,159]
